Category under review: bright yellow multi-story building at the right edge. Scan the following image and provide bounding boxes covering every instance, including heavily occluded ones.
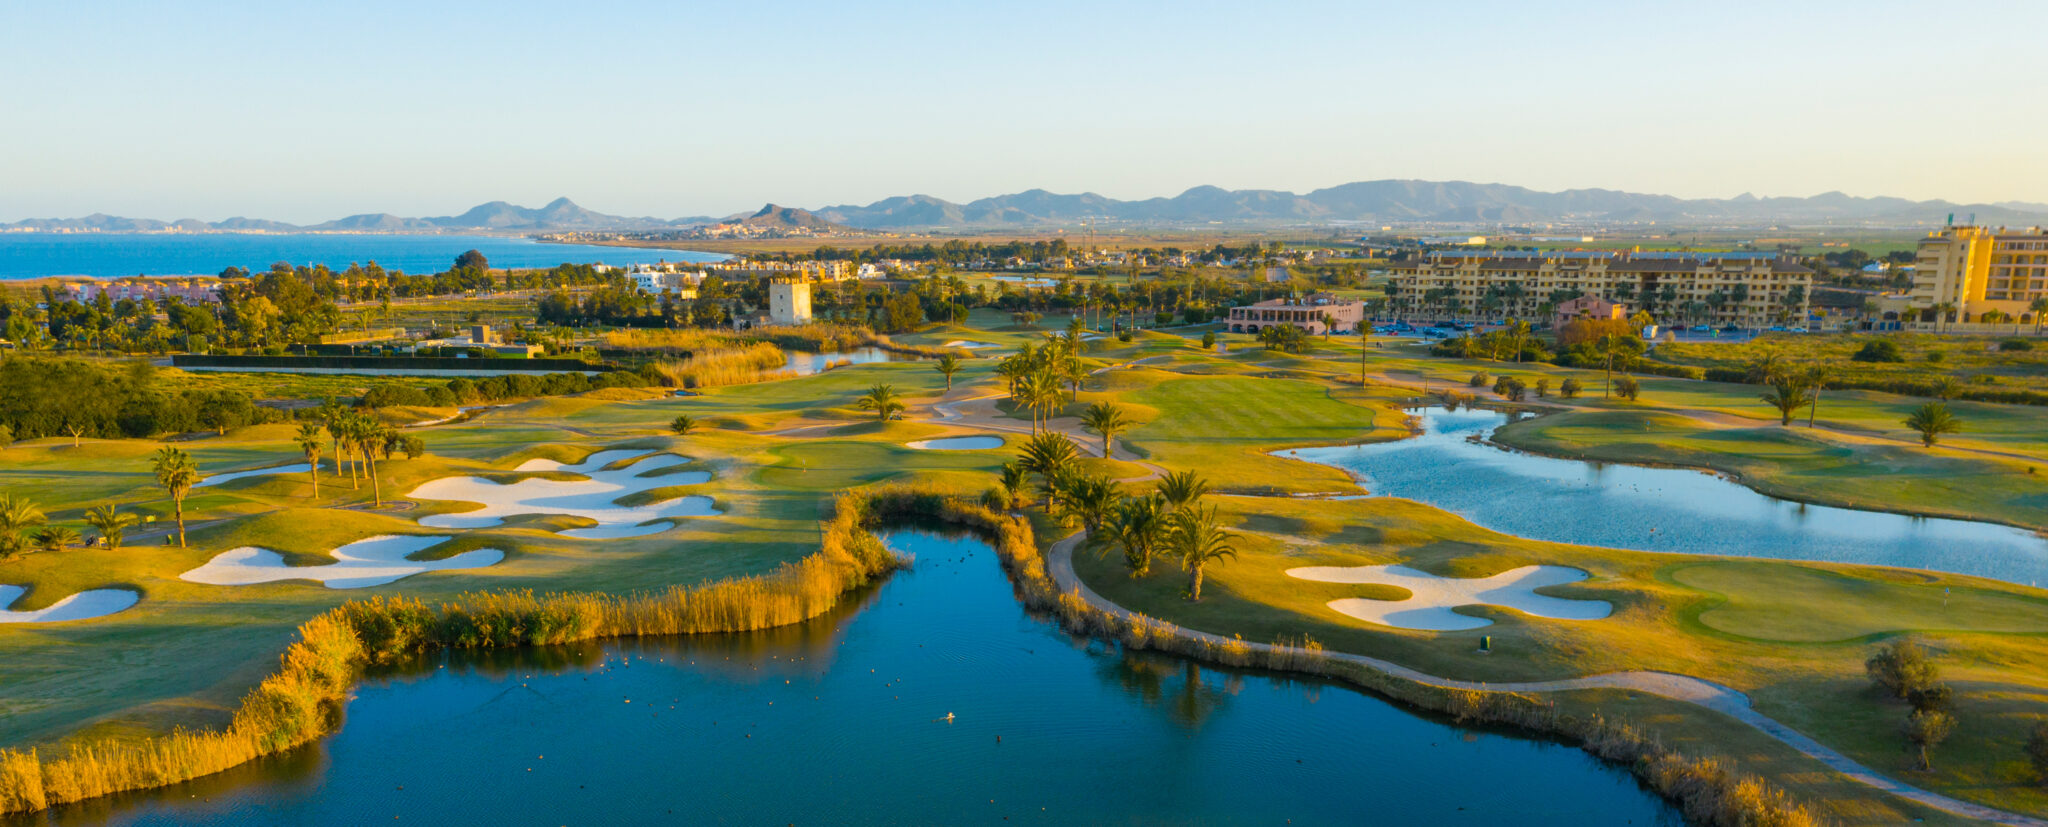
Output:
[1905,227,2048,323]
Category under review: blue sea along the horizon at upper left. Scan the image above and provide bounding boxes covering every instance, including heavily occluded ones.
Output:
[0,233,725,278]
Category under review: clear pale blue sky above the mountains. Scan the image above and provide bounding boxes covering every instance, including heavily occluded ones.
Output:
[0,0,2048,221]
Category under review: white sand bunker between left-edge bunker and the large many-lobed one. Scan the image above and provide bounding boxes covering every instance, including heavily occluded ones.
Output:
[178,534,506,590]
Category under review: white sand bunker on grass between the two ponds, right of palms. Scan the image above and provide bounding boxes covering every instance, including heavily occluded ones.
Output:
[1286,565,1614,633]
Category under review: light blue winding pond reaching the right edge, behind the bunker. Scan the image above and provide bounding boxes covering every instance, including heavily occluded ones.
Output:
[1280,407,2048,585]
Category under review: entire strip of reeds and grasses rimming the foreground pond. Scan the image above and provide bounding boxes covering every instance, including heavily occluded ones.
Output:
[0,485,1821,827]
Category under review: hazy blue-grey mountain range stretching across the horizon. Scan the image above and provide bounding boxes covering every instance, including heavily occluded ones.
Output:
[0,180,2048,233]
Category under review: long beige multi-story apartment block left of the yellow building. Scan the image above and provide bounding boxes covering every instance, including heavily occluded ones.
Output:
[1391,250,1812,328]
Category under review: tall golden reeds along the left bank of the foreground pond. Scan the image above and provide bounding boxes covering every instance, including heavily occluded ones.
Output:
[0,493,901,813]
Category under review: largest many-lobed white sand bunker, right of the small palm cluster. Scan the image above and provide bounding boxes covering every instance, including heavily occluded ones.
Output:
[408,450,719,540]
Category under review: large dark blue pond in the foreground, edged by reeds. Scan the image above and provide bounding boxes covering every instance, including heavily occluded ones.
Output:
[39,532,1681,827]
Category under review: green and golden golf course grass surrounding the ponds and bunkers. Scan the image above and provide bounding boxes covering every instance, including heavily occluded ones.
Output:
[0,311,2048,823]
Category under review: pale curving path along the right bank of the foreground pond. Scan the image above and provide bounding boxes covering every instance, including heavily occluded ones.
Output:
[1044,532,2048,827]
